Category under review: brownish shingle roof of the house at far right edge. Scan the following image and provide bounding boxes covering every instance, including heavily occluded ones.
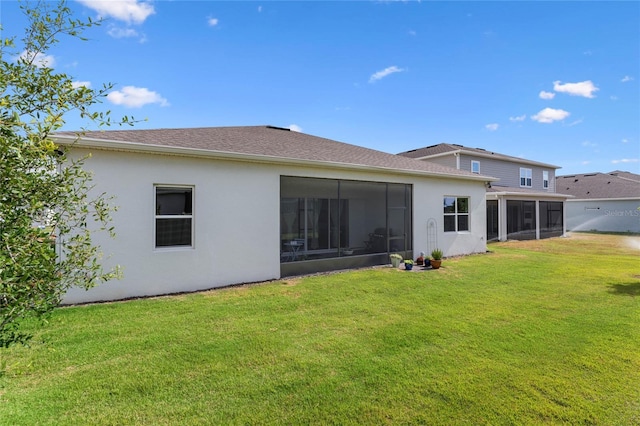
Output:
[556,171,640,199]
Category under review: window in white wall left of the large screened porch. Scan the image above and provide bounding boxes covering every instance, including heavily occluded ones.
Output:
[155,186,193,247]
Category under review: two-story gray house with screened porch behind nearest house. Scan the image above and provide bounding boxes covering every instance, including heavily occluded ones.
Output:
[399,143,569,241]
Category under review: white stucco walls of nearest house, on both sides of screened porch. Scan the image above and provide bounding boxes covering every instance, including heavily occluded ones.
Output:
[64,148,486,303]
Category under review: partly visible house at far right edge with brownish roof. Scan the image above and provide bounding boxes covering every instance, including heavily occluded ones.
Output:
[556,170,640,233]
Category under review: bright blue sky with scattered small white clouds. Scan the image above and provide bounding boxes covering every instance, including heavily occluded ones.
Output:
[0,0,640,175]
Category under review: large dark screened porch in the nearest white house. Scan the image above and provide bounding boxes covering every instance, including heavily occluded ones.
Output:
[280,176,412,276]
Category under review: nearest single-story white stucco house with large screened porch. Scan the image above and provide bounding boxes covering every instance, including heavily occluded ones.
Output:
[54,126,493,303]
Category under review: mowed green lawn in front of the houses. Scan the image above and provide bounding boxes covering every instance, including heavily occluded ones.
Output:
[0,234,640,425]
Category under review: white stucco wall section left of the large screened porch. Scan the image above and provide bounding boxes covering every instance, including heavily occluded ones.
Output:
[65,151,279,303]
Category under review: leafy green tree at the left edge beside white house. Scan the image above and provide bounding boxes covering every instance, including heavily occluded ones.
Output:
[0,1,131,347]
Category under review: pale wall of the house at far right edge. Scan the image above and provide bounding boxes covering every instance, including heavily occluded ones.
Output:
[565,199,640,232]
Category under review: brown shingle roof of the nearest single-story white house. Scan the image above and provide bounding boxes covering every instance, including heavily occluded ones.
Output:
[54,126,493,180]
